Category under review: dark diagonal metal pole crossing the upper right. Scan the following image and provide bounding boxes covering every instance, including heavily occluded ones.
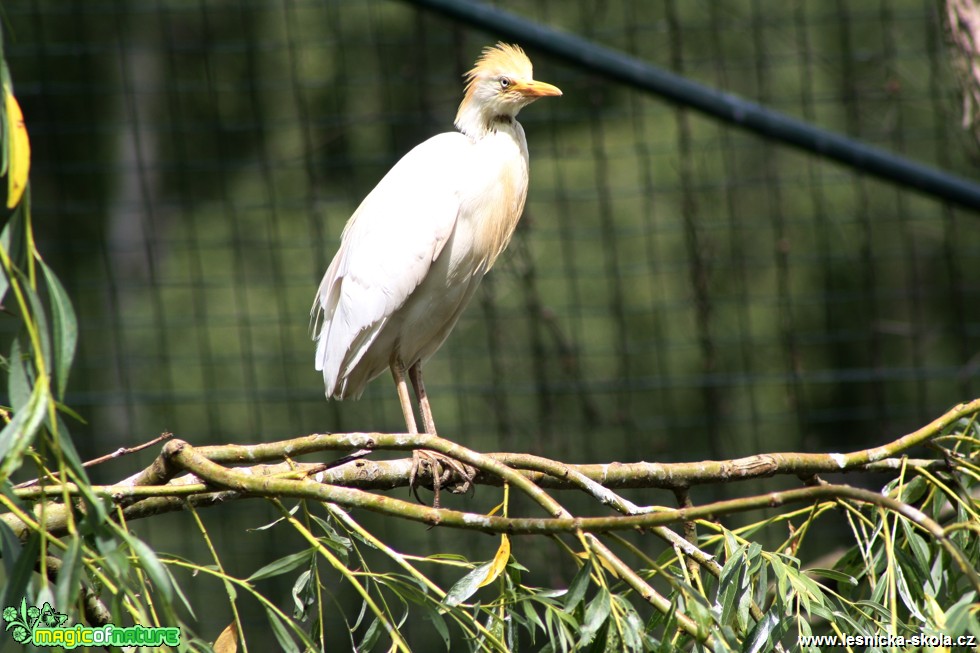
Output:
[404,0,980,210]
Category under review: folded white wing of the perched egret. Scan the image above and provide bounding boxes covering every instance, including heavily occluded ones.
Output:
[313,132,471,397]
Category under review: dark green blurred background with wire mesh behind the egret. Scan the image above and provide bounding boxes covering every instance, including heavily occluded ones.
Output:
[0,0,980,637]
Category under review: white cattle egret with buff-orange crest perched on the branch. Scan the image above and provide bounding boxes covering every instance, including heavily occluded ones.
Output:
[312,43,561,488]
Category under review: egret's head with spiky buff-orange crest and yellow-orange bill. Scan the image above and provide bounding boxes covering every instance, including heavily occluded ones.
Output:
[456,43,561,137]
